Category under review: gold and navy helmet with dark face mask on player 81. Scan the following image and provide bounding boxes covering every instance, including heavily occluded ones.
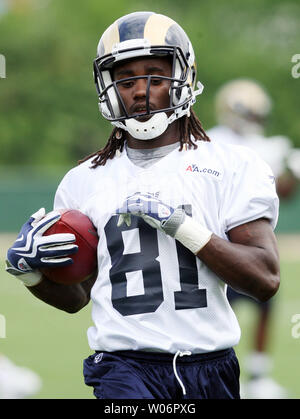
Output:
[94,12,203,139]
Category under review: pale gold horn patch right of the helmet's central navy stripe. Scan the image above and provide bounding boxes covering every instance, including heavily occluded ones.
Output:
[144,14,176,45]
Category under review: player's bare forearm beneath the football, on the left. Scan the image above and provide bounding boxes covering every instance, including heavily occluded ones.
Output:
[27,277,91,313]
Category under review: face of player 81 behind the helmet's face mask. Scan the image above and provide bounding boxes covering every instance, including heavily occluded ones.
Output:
[113,58,172,121]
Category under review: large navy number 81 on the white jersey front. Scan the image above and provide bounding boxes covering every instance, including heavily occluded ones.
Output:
[104,205,207,316]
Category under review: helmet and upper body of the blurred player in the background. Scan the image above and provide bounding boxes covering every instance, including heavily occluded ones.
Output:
[207,79,300,199]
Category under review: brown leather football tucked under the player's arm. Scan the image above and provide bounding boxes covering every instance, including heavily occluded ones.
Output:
[40,209,99,285]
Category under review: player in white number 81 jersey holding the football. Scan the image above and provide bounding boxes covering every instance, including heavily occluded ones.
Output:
[7,12,279,399]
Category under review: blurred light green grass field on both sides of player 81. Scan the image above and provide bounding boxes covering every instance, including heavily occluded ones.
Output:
[0,235,300,399]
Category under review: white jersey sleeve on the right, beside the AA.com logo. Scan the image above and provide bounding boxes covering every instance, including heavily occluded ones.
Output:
[223,147,279,232]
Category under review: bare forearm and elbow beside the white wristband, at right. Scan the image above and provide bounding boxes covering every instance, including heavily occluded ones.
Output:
[197,234,279,301]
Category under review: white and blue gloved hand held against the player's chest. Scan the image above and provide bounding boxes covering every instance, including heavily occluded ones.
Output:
[116,192,185,237]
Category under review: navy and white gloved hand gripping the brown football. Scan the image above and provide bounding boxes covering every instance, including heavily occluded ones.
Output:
[6,208,78,276]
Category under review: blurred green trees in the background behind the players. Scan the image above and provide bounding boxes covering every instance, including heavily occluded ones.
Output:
[0,0,300,167]
